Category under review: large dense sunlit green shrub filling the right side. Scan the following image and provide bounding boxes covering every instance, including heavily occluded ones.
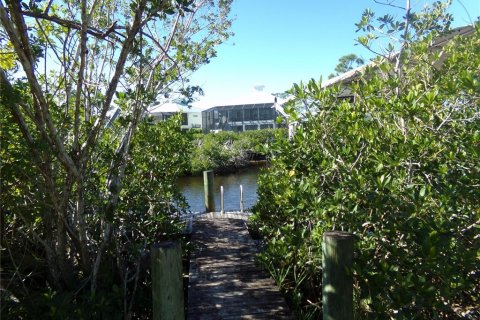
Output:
[251,18,480,319]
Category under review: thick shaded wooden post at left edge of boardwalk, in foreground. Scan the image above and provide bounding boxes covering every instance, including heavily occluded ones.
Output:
[152,241,185,320]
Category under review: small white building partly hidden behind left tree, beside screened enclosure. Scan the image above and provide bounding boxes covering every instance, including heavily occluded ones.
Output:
[149,102,202,130]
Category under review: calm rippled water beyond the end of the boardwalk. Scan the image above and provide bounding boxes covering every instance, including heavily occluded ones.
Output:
[178,168,259,212]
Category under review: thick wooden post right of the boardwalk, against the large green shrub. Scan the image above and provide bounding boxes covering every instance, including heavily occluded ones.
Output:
[322,231,354,320]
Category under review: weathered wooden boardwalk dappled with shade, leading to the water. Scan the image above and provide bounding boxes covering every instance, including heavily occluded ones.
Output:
[187,213,292,320]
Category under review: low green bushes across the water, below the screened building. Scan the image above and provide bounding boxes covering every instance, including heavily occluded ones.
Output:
[191,129,284,173]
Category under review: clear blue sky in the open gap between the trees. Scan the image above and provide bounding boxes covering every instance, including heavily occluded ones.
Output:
[191,0,480,107]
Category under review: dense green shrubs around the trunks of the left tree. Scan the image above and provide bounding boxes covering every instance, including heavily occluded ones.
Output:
[0,115,190,319]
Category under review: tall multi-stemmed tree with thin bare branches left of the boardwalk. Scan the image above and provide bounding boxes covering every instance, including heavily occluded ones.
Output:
[0,0,231,317]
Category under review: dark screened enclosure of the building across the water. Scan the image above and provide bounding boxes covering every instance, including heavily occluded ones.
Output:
[202,102,281,133]
